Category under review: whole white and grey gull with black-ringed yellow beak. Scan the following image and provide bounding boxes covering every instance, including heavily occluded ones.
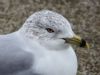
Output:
[0,10,89,75]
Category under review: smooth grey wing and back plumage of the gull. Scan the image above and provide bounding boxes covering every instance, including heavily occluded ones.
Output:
[0,33,41,75]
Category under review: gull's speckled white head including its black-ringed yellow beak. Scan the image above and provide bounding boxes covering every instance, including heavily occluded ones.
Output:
[20,10,88,49]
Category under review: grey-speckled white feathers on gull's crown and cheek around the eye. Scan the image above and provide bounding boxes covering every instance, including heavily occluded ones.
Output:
[20,10,74,39]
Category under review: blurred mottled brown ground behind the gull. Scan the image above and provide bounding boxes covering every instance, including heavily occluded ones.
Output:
[0,0,100,75]
